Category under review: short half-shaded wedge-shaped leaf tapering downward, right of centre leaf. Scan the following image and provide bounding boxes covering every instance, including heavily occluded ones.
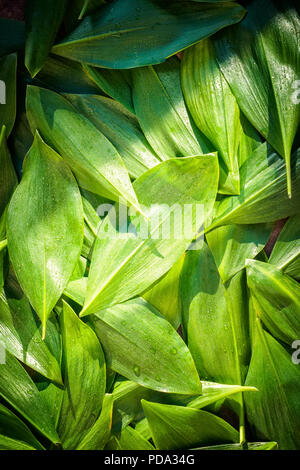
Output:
[206,224,272,282]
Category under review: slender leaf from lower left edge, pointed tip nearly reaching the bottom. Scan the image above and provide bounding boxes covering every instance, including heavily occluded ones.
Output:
[0,351,60,444]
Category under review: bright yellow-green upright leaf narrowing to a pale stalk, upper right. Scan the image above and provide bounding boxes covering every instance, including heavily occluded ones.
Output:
[181,39,241,194]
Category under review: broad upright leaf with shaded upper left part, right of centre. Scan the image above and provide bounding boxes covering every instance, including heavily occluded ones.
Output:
[181,245,250,385]
